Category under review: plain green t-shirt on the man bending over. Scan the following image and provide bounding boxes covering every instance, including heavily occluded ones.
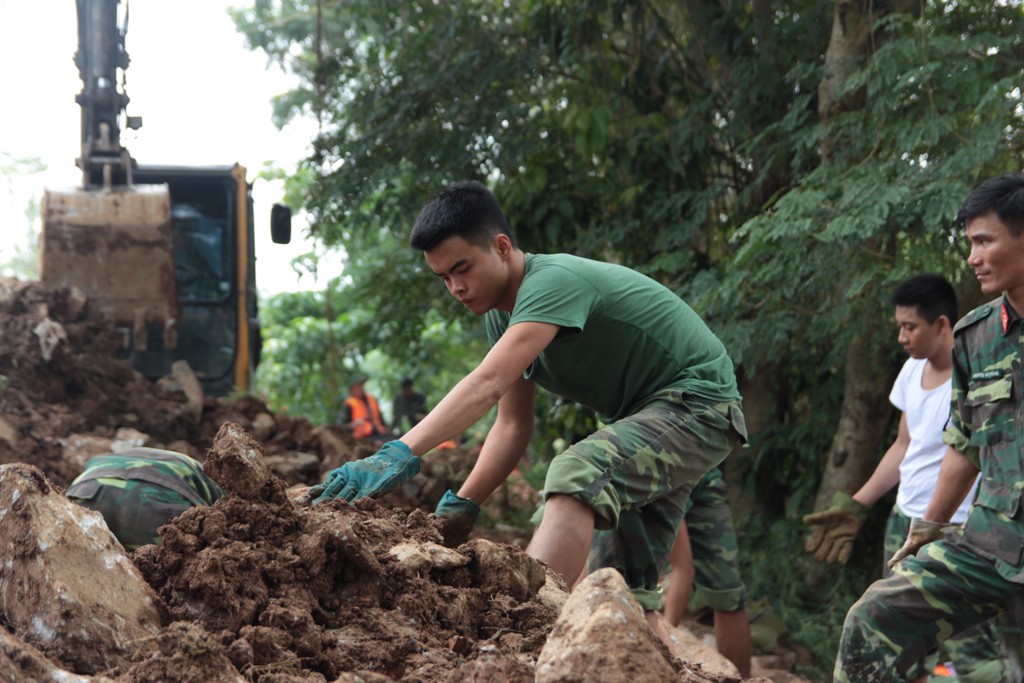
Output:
[484,254,739,422]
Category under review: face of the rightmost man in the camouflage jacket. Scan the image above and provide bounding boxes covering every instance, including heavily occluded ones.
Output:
[967,211,1024,294]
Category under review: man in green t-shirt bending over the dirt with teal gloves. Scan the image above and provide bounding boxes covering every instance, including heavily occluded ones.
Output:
[311,181,746,640]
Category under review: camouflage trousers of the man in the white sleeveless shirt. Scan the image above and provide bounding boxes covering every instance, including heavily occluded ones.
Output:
[882,506,1011,683]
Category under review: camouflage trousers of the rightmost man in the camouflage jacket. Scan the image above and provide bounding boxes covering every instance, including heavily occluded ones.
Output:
[834,535,1024,683]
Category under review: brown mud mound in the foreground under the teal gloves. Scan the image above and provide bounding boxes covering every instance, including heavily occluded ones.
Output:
[126,424,557,683]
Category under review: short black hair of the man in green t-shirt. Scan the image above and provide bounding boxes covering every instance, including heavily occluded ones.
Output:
[409,180,515,251]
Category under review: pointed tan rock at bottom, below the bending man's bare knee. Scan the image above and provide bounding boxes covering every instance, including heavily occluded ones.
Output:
[536,568,679,683]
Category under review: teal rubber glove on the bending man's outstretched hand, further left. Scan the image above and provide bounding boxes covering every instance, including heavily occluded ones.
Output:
[309,441,420,505]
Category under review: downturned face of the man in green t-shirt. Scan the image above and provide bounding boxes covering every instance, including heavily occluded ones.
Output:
[423,236,511,315]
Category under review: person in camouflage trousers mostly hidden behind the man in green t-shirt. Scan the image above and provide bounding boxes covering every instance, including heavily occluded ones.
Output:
[665,467,752,678]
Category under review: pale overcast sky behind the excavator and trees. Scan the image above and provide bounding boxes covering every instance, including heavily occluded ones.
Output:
[0,0,340,293]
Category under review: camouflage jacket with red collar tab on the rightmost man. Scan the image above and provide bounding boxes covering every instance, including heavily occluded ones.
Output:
[943,298,1024,584]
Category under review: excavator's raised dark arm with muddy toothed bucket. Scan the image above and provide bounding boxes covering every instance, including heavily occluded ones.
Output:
[40,0,180,349]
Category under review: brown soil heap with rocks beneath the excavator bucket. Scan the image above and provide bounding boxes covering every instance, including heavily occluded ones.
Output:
[0,279,436,497]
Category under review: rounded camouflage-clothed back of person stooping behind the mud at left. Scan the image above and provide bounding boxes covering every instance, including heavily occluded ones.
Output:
[68,449,224,550]
